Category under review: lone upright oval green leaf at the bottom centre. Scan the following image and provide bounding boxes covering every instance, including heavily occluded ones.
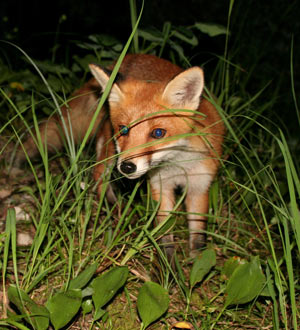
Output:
[137,282,170,328]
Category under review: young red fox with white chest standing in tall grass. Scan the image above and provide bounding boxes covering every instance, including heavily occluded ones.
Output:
[16,54,224,257]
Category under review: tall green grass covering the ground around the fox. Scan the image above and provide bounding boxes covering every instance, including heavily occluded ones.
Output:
[0,2,300,329]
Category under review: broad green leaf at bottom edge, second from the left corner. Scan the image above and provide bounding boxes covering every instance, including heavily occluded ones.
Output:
[46,290,82,329]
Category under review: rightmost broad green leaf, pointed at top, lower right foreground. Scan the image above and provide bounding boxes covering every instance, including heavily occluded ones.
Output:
[225,257,266,307]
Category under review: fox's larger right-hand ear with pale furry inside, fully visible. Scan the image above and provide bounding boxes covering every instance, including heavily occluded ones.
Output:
[162,67,204,110]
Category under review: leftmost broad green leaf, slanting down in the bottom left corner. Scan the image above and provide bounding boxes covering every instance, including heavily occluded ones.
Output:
[7,285,49,330]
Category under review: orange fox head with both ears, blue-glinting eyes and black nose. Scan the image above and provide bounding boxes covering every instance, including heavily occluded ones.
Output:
[90,64,204,179]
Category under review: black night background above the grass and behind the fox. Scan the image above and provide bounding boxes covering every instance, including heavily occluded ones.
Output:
[0,0,300,135]
